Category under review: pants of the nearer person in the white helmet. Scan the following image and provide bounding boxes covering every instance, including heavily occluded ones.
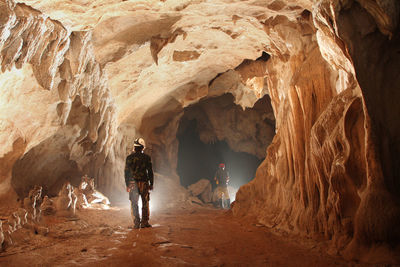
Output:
[129,181,150,225]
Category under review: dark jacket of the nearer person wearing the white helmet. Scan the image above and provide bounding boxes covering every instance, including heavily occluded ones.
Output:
[125,152,154,186]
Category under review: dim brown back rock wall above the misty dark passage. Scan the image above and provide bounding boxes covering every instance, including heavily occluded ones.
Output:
[178,94,275,159]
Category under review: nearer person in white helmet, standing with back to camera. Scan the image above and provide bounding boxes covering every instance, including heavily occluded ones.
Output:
[125,138,154,229]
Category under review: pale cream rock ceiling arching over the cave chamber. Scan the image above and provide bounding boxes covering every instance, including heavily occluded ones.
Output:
[17,0,311,125]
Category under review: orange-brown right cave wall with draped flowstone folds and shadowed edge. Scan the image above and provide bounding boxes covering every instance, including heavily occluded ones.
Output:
[233,1,400,262]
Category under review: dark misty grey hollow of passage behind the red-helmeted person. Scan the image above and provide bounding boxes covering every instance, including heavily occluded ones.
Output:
[177,120,261,191]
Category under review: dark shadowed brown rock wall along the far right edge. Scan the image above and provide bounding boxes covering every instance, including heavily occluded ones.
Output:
[336,1,400,254]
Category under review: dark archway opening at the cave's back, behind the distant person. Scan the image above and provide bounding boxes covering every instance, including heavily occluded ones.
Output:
[177,94,275,193]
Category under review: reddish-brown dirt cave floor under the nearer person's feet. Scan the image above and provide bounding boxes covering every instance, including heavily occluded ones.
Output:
[0,206,368,267]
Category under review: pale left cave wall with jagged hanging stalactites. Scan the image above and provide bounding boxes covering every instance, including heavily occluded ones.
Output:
[0,1,121,200]
